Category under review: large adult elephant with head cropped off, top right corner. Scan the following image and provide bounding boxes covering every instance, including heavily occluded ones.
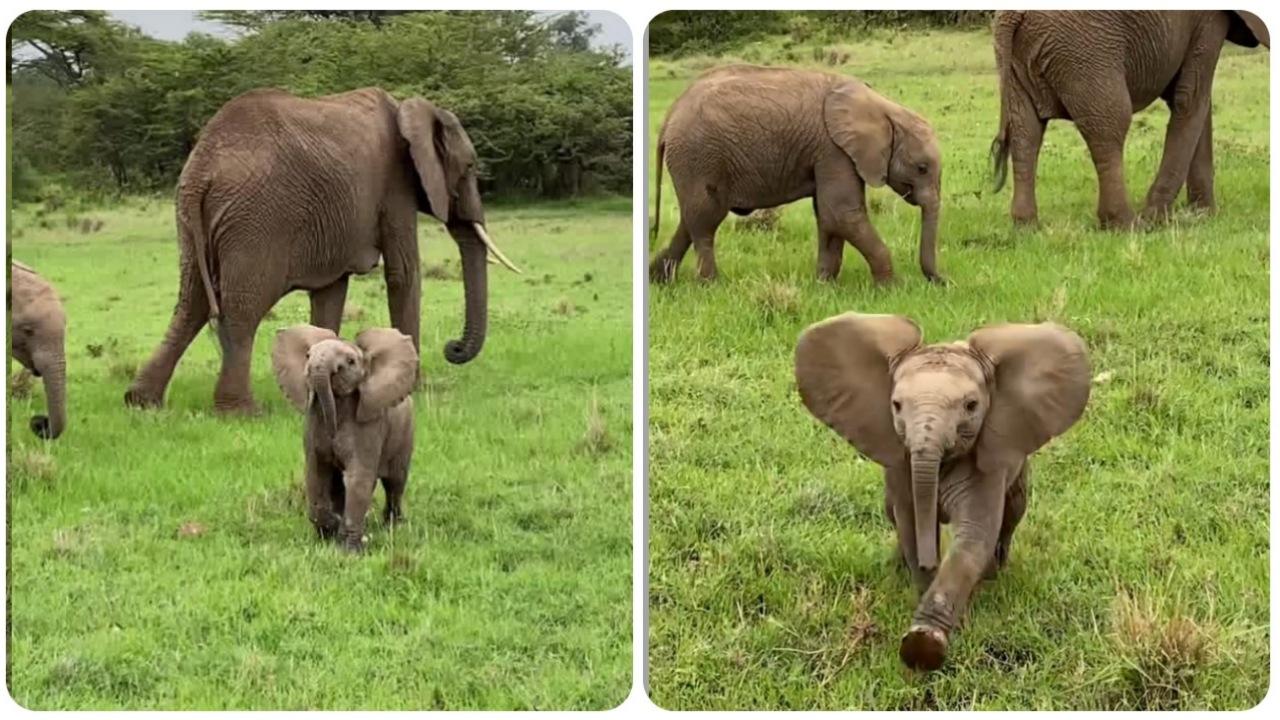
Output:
[991,10,1271,228]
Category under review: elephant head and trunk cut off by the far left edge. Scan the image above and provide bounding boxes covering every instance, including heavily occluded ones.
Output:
[9,261,67,439]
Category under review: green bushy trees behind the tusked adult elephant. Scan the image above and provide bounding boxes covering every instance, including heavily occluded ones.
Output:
[9,10,632,205]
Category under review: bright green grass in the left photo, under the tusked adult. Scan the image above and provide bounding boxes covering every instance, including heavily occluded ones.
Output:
[8,199,632,710]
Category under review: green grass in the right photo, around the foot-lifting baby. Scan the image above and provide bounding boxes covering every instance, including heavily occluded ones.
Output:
[646,26,1270,710]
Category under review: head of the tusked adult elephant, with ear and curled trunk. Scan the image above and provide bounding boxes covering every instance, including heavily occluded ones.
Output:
[396,97,520,365]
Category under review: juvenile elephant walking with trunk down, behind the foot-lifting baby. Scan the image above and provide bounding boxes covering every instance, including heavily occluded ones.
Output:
[649,65,943,283]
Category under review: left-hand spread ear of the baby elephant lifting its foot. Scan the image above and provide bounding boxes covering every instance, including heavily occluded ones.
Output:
[795,313,922,466]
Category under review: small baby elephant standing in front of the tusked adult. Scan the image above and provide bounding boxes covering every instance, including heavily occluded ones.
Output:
[271,324,417,551]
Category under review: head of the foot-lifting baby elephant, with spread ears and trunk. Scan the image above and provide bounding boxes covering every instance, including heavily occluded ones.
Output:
[795,313,1091,573]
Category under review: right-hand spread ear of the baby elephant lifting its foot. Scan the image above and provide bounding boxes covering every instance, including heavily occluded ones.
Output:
[969,323,1091,473]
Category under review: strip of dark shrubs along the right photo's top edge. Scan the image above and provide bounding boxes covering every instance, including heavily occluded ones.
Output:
[649,10,993,58]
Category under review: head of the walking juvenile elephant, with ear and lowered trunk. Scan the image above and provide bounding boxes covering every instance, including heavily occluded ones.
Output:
[823,79,942,278]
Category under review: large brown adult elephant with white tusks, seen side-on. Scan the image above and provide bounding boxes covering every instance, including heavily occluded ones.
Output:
[124,88,520,414]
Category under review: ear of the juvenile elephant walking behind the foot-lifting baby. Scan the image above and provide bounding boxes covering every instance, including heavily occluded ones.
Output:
[822,82,893,187]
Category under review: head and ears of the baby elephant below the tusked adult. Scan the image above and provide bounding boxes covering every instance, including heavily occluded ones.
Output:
[271,324,417,437]
